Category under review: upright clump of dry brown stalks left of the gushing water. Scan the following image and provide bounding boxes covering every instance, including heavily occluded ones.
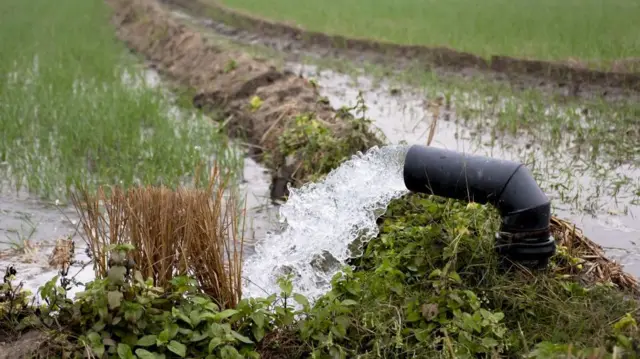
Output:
[72,166,244,308]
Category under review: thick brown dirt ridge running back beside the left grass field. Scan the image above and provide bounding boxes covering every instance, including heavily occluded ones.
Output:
[107,0,382,198]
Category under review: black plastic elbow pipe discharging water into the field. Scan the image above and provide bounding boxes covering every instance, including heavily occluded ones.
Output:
[404,145,556,265]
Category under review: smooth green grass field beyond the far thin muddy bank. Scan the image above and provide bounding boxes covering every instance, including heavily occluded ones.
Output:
[216,0,640,61]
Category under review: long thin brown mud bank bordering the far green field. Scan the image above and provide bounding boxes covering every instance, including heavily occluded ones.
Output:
[162,0,640,100]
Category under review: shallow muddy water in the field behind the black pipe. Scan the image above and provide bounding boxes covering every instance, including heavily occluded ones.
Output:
[286,63,640,275]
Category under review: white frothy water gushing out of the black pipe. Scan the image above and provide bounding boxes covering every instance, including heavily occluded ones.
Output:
[243,145,408,300]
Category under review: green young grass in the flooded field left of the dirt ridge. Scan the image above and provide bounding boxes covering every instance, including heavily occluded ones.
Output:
[0,0,241,199]
